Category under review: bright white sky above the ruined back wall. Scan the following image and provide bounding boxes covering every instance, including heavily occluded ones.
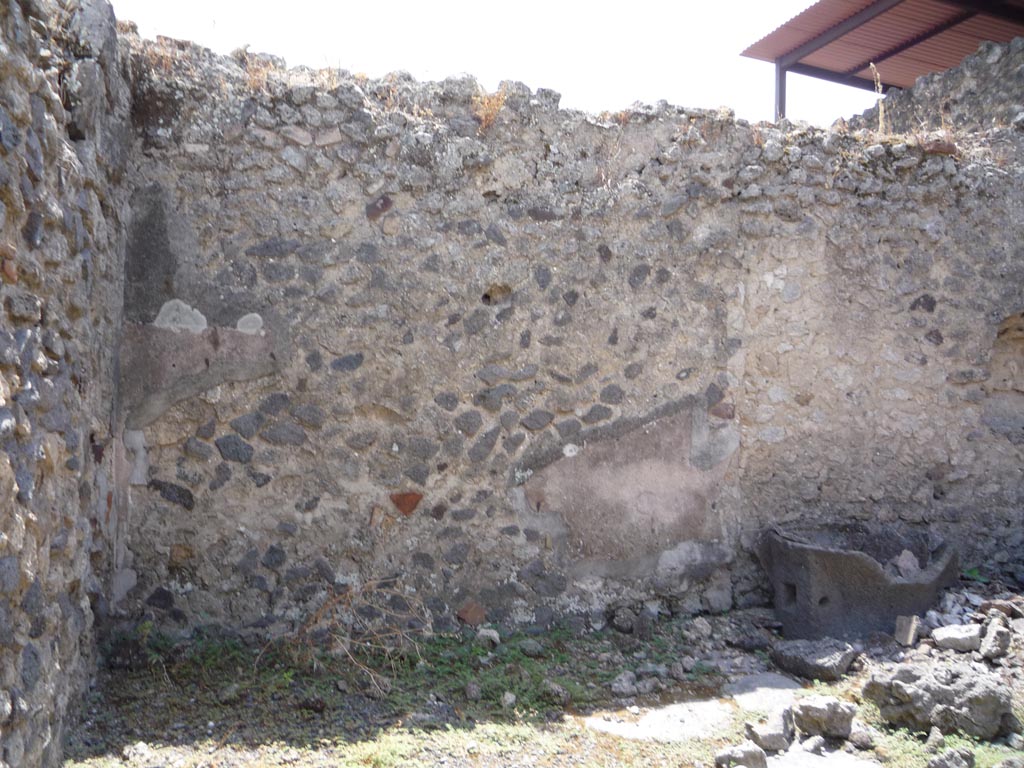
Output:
[112,0,874,126]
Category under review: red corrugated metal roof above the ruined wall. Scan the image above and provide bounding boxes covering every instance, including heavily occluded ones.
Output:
[743,0,1024,88]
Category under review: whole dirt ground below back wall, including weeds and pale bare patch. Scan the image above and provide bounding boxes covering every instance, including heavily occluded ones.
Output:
[65,593,1024,768]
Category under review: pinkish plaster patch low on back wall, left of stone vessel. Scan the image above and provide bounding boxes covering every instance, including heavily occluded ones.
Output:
[524,397,739,593]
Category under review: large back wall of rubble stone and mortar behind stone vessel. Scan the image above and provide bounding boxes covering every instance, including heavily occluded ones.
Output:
[116,33,1024,633]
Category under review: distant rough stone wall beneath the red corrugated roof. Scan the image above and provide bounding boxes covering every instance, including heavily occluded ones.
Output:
[851,37,1024,133]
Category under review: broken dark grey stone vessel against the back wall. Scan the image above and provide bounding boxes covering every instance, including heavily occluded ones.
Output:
[758,523,958,639]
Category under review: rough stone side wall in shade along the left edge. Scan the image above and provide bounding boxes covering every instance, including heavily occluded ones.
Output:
[0,0,130,768]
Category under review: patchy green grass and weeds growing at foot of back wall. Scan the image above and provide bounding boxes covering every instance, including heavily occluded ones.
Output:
[65,621,1024,768]
